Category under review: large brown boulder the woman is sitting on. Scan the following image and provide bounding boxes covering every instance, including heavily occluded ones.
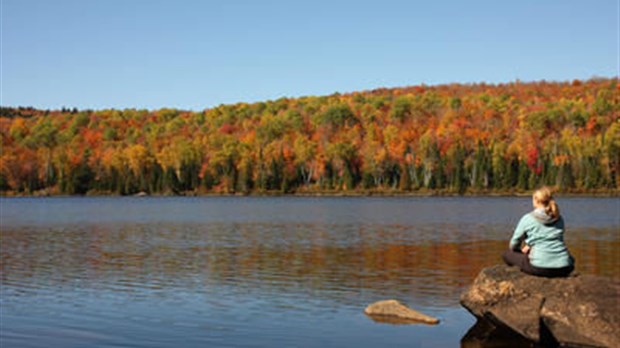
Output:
[461,266,620,347]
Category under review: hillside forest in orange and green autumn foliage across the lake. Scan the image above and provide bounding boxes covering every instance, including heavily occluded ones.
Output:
[0,78,620,195]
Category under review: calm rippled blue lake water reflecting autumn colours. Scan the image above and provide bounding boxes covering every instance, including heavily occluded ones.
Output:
[0,197,620,347]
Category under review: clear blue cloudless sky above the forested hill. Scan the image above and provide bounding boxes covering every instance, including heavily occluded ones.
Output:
[0,0,619,110]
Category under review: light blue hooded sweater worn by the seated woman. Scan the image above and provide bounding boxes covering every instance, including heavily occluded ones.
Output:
[510,209,574,268]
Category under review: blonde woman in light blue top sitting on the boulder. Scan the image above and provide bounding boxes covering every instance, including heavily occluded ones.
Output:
[503,187,575,277]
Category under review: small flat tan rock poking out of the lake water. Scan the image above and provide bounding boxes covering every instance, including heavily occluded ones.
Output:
[364,300,439,324]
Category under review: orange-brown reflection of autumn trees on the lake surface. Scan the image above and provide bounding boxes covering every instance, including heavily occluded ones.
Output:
[0,223,620,304]
